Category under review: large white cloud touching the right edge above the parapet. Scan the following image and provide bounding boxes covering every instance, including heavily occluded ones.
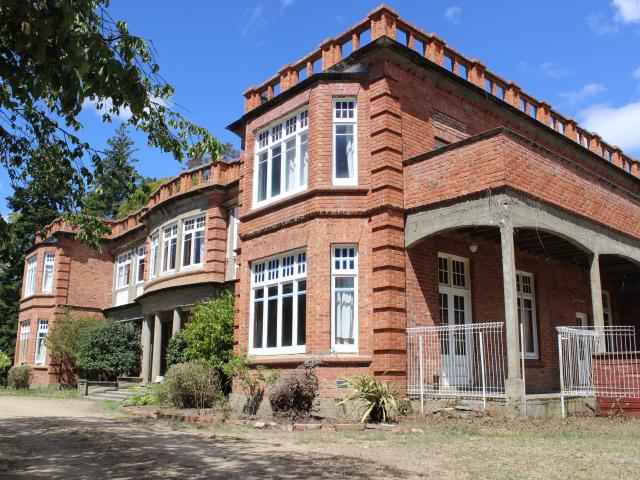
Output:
[578,102,640,154]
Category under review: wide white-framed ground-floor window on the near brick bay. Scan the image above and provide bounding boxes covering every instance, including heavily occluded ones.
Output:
[249,249,308,356]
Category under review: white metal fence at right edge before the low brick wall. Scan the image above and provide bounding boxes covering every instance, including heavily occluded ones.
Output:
[556,326,640,416]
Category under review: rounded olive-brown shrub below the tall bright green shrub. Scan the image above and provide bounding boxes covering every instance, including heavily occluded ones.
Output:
[164,361,222,410]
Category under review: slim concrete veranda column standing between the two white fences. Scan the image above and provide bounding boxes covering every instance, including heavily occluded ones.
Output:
[500,221,524,406]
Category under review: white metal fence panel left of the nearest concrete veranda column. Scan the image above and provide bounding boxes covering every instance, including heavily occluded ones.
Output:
[407,322,506,405]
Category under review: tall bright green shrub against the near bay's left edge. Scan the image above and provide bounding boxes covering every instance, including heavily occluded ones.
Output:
[183,291,235,371]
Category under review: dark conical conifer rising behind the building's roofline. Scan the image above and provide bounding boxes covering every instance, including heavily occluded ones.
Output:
[84,123,140,218]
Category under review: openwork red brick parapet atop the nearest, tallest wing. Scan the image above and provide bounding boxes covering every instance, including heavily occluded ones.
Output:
[244,4,640,176]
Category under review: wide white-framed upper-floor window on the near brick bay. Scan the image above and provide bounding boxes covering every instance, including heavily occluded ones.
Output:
[253,105,309,208]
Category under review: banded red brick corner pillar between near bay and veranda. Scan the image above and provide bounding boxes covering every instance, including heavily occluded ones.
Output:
[370,64,407,391]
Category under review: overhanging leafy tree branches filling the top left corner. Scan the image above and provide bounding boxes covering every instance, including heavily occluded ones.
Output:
[0,0,223,246]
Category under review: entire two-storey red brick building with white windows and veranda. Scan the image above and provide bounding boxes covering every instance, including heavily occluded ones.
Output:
[16,6,640,402]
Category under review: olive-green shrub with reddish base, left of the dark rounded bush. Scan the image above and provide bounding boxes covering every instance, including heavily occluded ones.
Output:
[46,312,104,385]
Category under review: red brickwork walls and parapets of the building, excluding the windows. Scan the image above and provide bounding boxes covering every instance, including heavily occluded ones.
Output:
[20,5,640,398]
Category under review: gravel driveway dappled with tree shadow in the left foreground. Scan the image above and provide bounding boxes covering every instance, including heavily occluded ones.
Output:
[0,417,412,479]
